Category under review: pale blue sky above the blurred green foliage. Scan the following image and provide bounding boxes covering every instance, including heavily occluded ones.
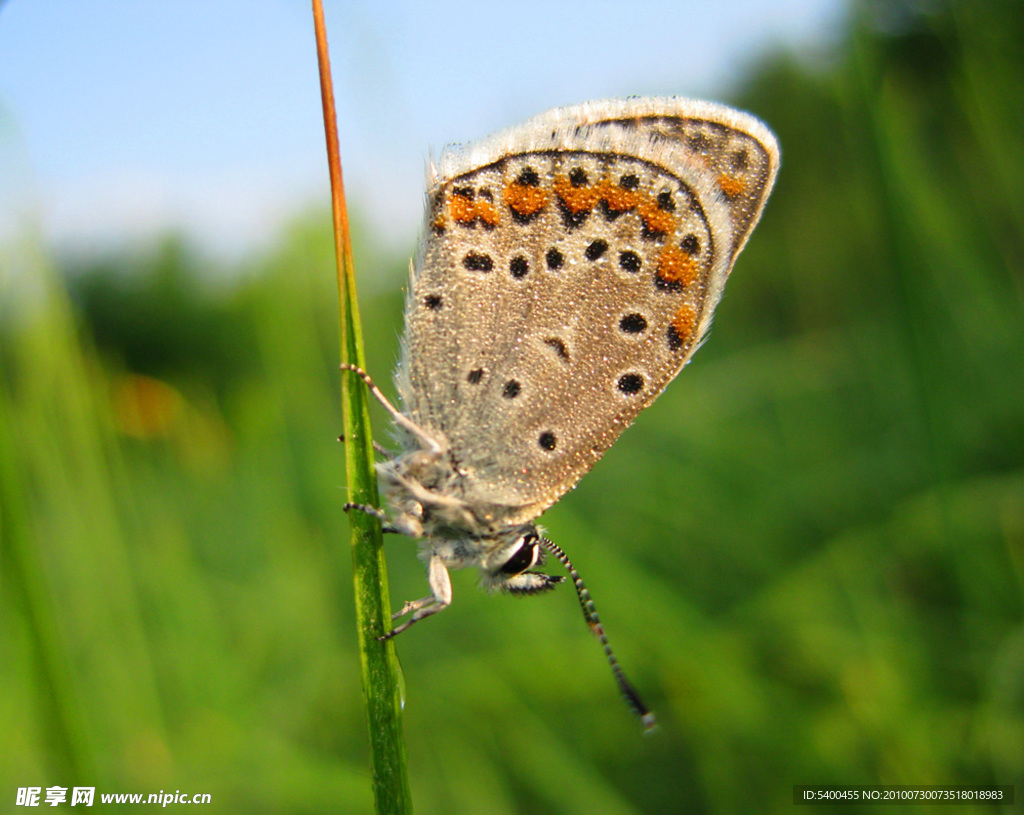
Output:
[0,0,846,259]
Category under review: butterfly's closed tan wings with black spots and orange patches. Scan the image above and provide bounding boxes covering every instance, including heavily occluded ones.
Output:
[398,99,778,523]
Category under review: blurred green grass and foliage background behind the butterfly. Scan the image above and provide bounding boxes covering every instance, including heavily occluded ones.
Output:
[0,2,1024,813]
